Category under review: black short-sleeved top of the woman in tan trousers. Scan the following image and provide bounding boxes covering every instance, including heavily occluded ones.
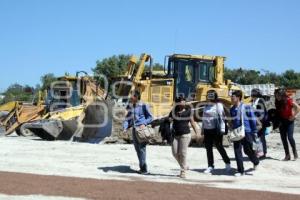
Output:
[169,109,192,136]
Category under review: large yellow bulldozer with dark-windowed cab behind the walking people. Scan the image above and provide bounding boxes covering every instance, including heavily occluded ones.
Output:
[112,54,250,142]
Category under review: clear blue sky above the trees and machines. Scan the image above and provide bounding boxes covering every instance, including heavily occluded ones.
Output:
[0,0,300,91]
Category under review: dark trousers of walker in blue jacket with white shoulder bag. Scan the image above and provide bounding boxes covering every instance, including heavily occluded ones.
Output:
[233,134,259,173]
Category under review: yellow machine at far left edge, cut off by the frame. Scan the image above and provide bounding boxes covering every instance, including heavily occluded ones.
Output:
[0,92,45,136]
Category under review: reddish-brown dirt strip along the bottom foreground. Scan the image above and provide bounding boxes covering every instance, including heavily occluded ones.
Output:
[0,172,300,200]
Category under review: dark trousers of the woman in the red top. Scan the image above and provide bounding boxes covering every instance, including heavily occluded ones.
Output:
[279,120,296,156]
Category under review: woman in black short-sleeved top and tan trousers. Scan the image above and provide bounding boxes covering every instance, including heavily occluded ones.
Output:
[169,97,200,178]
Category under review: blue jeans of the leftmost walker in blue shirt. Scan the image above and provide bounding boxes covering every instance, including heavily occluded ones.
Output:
[132,128,148,171]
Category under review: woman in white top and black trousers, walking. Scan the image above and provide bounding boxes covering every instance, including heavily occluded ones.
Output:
[202,90,231,174]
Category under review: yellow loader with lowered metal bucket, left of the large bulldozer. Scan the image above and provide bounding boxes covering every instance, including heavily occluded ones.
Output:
[24,72,112,143]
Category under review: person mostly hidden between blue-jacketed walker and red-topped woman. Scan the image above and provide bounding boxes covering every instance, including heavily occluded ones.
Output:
[251,89,271,159]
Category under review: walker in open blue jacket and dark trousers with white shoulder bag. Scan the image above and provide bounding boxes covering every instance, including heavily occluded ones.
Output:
[230,90,259,177]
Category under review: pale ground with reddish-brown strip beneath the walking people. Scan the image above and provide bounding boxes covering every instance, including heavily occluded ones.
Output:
[0,121,300,200]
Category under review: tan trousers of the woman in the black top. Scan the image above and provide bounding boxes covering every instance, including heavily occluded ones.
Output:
[178,134,191,171]
